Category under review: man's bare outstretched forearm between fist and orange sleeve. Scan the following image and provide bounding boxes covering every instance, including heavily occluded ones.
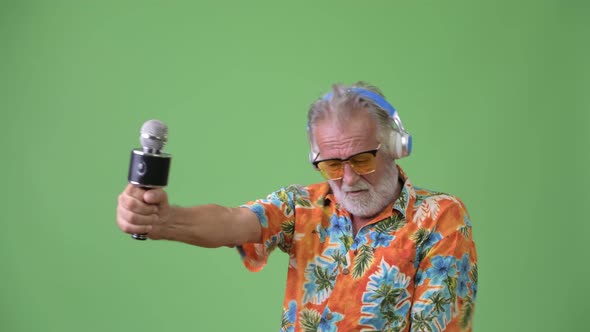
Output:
[150,204,261,248]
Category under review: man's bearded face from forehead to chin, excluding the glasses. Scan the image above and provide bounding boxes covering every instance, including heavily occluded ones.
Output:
[314,113,398,218]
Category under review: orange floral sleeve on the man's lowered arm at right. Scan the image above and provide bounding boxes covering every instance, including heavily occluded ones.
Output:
[410,201,477,331]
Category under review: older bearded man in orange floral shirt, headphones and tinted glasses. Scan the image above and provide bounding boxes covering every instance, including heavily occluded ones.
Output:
[117,82,477,331]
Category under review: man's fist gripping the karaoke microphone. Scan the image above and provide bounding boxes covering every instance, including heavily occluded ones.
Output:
[117,184,171,239]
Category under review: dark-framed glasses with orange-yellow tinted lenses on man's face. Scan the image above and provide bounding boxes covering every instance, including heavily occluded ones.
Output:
[312,144,381,180]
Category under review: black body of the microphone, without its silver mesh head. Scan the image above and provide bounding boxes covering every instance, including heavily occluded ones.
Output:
[127,149,172,240]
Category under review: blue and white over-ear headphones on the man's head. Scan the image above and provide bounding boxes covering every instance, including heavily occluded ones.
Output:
[309,88,412,162]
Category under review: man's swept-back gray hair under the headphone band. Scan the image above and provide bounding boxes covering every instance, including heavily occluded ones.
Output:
[307,82,394,155]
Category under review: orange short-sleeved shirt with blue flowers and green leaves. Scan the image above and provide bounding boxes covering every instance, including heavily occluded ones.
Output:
[238,168,477,331]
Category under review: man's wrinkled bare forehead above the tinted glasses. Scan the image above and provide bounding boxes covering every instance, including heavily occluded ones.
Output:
[314,113,378,158]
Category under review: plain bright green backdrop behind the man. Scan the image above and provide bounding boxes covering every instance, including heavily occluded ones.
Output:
[0,0,590,332]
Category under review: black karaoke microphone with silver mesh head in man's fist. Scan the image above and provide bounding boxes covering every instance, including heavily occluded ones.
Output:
[127,120,172,240]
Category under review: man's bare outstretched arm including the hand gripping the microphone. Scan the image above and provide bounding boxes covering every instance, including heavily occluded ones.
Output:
[117,185,262,248]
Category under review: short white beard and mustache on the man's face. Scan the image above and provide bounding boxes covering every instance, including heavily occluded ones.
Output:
[329,163,399,218]
